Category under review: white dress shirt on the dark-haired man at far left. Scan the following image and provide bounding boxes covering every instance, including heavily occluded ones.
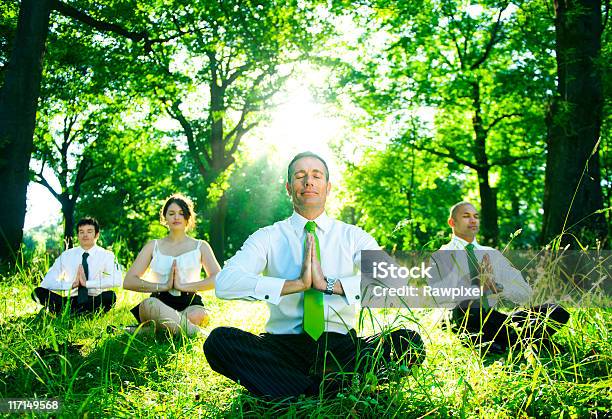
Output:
[40,245,123,296]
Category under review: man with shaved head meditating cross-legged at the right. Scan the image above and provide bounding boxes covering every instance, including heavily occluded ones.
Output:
[433,201,569,353]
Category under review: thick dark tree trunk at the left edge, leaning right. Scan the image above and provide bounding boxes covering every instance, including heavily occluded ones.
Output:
[0,0,51,262]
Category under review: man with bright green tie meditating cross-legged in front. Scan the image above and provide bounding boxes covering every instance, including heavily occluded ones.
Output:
[204,152,424,398]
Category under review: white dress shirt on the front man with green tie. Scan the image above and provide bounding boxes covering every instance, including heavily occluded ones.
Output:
[215,212,380,334]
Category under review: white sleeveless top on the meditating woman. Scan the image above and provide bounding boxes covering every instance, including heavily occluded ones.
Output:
[149,240,202,296]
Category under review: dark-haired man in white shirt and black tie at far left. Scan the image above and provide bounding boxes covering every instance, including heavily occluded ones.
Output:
[32,218,123,314]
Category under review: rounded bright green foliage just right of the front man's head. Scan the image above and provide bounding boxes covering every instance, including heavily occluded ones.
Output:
[342,136,465,252]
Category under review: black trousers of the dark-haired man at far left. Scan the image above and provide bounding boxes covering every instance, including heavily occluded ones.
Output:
[32,287,117,314]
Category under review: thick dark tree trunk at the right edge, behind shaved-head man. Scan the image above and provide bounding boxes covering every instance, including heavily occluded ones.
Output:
[541,0,607,245]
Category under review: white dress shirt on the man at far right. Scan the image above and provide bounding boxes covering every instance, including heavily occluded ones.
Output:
[432,235,533,308]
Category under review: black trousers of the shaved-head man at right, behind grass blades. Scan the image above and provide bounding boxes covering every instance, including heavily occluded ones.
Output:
[452,304,570,350]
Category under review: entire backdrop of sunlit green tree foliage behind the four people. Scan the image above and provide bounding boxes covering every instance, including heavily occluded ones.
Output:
[15,0,612,257]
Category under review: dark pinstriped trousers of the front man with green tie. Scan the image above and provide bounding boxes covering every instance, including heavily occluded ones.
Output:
[204,327,425,398]
